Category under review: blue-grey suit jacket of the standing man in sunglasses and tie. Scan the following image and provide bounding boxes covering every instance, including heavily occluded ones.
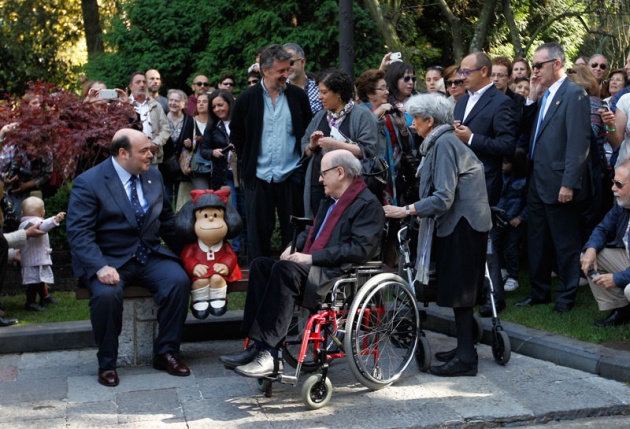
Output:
[527,78,592,204]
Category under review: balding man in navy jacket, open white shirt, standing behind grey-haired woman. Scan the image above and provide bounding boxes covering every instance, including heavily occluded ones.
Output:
[454,52,517,317]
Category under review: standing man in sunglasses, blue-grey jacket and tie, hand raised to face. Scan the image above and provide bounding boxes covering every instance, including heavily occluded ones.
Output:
[516,43,592,313]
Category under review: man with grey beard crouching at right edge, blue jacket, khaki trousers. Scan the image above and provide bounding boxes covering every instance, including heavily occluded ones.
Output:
[580,161,630,326]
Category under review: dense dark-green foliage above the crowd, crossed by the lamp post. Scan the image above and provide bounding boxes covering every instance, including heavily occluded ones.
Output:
[88,0,386,93]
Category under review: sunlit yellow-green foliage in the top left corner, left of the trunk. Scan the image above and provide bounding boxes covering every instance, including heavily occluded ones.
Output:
[0,0,82,94]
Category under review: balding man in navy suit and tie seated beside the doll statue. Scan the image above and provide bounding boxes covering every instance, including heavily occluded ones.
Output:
[67,129,190,386]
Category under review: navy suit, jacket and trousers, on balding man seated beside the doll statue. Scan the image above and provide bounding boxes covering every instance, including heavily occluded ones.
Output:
[67,158,190,369]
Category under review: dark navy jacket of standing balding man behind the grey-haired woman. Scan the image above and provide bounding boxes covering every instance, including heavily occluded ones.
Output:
[455,85,517,206]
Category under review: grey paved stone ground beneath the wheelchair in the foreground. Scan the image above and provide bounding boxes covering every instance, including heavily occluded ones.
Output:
[0,332,630,429]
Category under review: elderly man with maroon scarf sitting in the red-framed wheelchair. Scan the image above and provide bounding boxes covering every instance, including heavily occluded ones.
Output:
[219,149,385,378]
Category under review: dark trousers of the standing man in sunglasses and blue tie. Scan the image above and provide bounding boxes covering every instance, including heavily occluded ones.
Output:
[527,180,581,306]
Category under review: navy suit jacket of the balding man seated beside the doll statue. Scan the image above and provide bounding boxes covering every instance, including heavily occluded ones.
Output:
[66,157,181,278]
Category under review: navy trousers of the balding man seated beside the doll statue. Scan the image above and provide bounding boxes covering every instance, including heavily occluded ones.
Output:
[84,254,190,369]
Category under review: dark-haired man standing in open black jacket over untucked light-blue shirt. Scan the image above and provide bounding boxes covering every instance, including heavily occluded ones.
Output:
[230,45,312,262]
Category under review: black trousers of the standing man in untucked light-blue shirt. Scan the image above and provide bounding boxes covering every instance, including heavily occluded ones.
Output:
[245,177,304,263]
